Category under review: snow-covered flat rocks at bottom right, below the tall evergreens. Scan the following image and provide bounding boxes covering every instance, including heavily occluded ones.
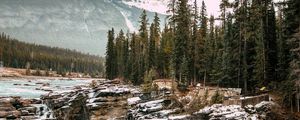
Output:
[128,97,275,120]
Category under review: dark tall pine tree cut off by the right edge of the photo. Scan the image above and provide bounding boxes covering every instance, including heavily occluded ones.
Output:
[282,0,300,112]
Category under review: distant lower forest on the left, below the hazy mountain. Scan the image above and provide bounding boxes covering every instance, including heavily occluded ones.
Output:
[0,33,104,76]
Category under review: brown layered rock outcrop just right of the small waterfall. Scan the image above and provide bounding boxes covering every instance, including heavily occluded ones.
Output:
[42,80,135,120]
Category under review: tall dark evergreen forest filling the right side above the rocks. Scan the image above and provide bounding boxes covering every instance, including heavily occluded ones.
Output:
[106,0,300,109]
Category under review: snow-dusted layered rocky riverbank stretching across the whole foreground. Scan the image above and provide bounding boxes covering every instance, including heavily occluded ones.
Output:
[0,80,290,120]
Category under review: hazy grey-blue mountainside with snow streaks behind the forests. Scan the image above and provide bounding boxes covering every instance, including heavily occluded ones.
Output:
[0,0,165,56]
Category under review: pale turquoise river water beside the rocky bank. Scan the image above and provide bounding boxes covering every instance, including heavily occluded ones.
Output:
[0,78,92,98]
